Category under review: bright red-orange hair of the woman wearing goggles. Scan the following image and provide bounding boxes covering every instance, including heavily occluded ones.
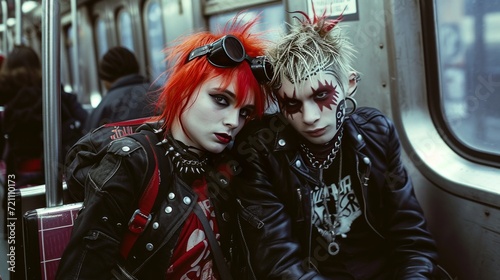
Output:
[156,17,266,129]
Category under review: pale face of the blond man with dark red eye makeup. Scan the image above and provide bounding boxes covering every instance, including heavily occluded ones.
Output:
[278,70,345,144]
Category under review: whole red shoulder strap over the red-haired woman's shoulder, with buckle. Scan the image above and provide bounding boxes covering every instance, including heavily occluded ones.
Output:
[121,130,160,259]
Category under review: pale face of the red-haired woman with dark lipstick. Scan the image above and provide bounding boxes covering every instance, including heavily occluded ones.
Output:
[172,77,254,153]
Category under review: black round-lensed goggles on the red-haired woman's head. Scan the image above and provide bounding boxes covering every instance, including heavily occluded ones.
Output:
[187,35,273,84]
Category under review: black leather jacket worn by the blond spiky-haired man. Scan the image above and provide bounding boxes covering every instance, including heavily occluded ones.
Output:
[232,108,437,280]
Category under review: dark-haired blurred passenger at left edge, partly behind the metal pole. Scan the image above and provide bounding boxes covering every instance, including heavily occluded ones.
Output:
[0,45,87,186]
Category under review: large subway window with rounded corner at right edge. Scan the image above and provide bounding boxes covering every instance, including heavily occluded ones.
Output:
[435,0,500,156]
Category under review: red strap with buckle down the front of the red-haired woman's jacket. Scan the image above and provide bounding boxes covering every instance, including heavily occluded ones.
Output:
[121,135,160,259]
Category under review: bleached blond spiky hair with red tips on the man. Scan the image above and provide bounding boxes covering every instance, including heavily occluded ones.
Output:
[267,9,355,94]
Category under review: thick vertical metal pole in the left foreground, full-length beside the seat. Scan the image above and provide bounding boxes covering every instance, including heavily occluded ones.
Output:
[42,0,63,207]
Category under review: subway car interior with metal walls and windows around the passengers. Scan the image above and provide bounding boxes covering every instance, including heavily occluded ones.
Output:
[0,0,500,280]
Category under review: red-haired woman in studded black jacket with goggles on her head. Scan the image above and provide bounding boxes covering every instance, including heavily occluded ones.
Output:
[57,16,272,279]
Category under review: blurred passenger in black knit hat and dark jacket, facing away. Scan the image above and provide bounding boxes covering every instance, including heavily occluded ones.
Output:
[85,47,155,131]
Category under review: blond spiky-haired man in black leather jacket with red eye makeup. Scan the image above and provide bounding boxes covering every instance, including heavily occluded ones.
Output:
[232,7,446,279]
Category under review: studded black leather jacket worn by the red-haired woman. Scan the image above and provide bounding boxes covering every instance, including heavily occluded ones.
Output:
[56,132,232,279]
